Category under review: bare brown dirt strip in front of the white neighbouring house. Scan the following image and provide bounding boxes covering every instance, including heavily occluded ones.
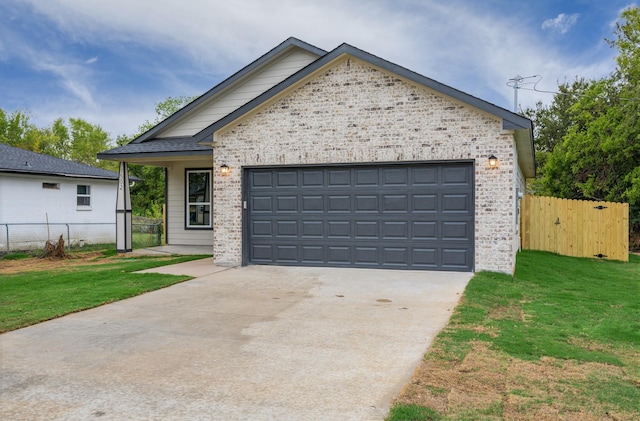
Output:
[0,251,124,275]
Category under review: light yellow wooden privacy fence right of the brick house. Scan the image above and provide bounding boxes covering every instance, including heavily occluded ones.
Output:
[520,196,629,262]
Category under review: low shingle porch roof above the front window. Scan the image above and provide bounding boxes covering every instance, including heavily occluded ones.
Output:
[98,137,213,159]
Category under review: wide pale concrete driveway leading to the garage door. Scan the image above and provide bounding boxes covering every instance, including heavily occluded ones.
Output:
[0,261,471,420]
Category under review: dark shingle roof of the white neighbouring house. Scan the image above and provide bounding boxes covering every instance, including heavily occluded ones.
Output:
[0,143,118,180]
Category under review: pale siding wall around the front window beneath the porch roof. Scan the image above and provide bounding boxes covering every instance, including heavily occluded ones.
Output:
[167,158,215,246]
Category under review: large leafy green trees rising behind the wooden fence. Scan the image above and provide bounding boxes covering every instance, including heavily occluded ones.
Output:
[530,7,640,238]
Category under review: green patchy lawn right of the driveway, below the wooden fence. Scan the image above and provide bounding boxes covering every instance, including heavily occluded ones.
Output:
[387,251,640,421]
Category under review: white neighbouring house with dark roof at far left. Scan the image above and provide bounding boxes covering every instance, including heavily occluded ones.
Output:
[0,143,118,252]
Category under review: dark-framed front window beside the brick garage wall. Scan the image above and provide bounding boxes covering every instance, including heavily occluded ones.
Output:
[186,170,211,228]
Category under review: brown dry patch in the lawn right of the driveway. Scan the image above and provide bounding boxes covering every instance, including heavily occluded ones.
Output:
[395,342,638,421]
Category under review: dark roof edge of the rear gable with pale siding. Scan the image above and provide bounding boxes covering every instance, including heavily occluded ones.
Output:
[131,37,327,143]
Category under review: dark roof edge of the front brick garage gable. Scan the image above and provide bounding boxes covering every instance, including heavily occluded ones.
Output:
[194,44,533,143]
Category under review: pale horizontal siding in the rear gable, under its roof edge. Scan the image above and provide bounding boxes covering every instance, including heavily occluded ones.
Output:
[157,49,317,137]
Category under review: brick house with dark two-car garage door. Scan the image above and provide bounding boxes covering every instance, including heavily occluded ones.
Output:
[98,38,535,273]
